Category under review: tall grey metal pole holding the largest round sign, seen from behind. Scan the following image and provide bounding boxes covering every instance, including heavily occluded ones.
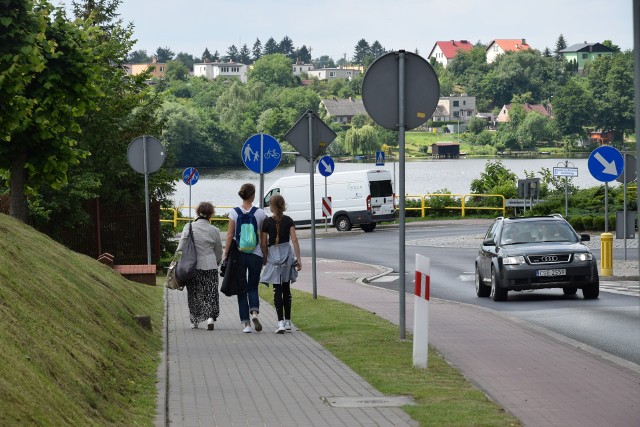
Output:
[398,50,406,339]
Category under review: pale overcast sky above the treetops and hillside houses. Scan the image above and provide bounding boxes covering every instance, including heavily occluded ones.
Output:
[56,0,633,60]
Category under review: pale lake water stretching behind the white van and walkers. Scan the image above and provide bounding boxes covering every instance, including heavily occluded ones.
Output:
[173,157,619,211]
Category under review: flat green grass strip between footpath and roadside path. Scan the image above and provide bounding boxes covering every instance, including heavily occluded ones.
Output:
[260,286,520,427]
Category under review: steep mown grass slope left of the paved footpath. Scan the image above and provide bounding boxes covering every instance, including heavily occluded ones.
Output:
[0,214,164,426]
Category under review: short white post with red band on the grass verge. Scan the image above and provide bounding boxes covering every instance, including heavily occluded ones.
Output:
[413,254,431,368]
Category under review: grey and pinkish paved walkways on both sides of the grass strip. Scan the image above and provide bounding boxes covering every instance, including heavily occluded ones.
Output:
[156,254,640,427]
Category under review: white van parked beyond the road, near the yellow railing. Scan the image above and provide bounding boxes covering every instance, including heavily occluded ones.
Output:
[263,170,396,231]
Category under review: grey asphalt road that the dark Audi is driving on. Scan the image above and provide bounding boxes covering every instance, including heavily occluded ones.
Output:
[300,224,640,364]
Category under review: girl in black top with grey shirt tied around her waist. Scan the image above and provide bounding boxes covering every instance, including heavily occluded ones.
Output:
[260,194,302,334]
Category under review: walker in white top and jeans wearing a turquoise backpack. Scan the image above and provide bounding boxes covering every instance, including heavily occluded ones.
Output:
[224,183,267,333]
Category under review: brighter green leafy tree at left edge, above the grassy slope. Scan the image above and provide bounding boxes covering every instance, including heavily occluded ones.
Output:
[0,0,101,221]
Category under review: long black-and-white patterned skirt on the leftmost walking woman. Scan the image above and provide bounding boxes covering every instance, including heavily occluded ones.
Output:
[187,269,220,323]
